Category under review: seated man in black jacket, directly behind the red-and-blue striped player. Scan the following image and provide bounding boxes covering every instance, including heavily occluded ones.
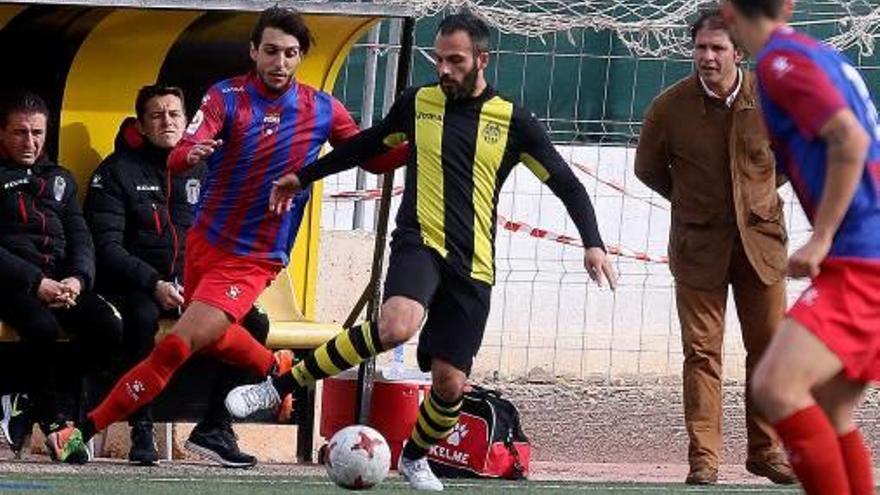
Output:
[85,85,269,467]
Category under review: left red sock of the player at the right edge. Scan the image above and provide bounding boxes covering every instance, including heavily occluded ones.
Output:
[775,405,850,495]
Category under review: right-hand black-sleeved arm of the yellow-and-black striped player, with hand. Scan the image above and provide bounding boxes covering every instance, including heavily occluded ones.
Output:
[520,110,617,290]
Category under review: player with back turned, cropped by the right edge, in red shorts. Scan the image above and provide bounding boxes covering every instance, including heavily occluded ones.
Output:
[723,0,880,495]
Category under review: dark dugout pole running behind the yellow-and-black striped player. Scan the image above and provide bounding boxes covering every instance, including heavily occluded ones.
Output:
[356,17,416,424]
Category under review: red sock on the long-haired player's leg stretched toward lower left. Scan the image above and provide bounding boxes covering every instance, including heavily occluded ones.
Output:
[89,334,190,431]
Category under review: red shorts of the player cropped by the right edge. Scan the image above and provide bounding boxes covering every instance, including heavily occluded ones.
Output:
[788,258,880,382]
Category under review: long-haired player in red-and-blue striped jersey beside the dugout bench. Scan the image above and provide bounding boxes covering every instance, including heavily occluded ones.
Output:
[50,7,407,462]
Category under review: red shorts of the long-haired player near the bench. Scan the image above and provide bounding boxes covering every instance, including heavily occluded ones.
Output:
[183,229,283,322]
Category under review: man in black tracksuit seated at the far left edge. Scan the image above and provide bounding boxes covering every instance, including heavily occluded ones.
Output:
[0,92,122,460]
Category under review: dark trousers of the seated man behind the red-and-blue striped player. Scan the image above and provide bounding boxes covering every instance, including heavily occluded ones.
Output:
[108,290,269,427]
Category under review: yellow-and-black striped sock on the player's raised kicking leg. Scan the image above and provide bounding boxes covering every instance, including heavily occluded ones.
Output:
[273,321,385,397]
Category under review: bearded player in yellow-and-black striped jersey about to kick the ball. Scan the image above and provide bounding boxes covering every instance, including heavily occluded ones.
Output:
[227,14,616,490]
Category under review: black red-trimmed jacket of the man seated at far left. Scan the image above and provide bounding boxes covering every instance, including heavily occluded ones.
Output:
[0,157,95,293]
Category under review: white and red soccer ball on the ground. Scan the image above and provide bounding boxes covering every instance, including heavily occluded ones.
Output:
[324,425,391,490]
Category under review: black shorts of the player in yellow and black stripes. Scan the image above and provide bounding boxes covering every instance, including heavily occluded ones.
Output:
[384,243,492,375]
